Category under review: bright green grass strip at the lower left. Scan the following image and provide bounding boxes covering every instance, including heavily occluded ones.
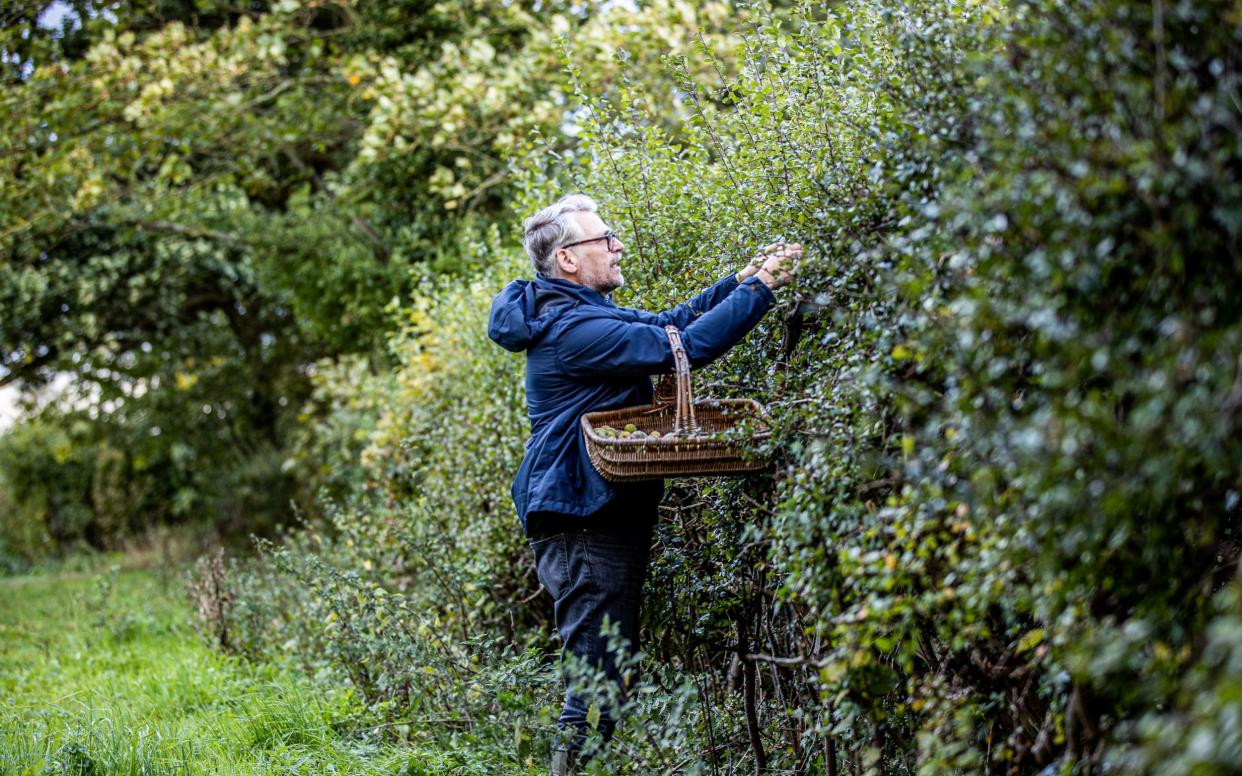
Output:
[0,569,529,776]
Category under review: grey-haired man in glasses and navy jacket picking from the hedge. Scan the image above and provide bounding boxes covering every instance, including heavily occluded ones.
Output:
[488,195,802,775]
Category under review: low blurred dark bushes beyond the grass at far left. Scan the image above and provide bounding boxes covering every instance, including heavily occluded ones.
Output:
[0,406,297,567]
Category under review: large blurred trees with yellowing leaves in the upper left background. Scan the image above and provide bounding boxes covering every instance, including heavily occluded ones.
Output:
[0,0,729,556]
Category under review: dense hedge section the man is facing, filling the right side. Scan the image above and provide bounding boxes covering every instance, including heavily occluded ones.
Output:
[536,2,1242,774]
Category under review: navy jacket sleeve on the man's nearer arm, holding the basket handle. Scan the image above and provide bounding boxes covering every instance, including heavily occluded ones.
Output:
[556,278,775,377]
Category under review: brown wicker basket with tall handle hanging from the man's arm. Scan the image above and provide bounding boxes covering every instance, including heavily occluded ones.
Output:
[582,327,771,482]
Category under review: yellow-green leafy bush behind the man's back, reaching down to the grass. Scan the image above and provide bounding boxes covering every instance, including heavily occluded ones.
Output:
[191,245,554,757]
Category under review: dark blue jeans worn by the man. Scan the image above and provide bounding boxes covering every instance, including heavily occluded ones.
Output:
[530,520,652,749]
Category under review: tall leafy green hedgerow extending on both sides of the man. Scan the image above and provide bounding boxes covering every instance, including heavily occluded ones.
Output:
[206,0,1242,774]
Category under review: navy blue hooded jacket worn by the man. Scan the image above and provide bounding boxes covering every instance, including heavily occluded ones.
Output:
[488,274,775,530]
